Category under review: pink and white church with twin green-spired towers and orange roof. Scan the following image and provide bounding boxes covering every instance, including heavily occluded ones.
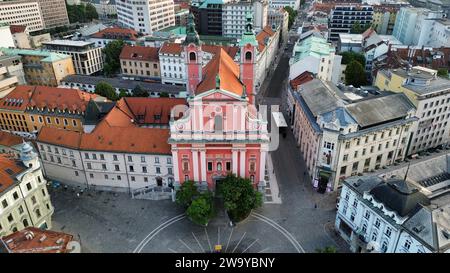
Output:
[169,13,269,190]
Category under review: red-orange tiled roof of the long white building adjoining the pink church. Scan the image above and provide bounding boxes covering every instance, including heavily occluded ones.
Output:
[37,98,186,154]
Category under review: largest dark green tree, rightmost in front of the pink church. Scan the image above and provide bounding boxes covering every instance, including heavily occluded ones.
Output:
[220,174,262,222]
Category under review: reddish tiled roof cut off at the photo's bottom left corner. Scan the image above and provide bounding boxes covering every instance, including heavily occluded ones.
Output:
[2,227,73,253]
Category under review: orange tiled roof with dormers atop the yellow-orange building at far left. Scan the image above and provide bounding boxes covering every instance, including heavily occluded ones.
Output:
[0,85,98,111]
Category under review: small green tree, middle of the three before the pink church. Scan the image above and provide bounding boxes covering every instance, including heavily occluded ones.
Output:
[186,192,214,226]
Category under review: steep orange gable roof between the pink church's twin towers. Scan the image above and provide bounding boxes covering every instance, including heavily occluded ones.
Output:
[196,49,243,96]
